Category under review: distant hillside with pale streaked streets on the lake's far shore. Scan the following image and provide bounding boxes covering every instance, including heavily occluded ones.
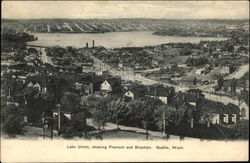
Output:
[1,18,248,36]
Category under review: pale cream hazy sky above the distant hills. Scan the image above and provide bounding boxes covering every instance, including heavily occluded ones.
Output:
[1,0,249,19]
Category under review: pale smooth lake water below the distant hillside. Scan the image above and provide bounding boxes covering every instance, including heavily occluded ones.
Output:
[28,31,227,48]
